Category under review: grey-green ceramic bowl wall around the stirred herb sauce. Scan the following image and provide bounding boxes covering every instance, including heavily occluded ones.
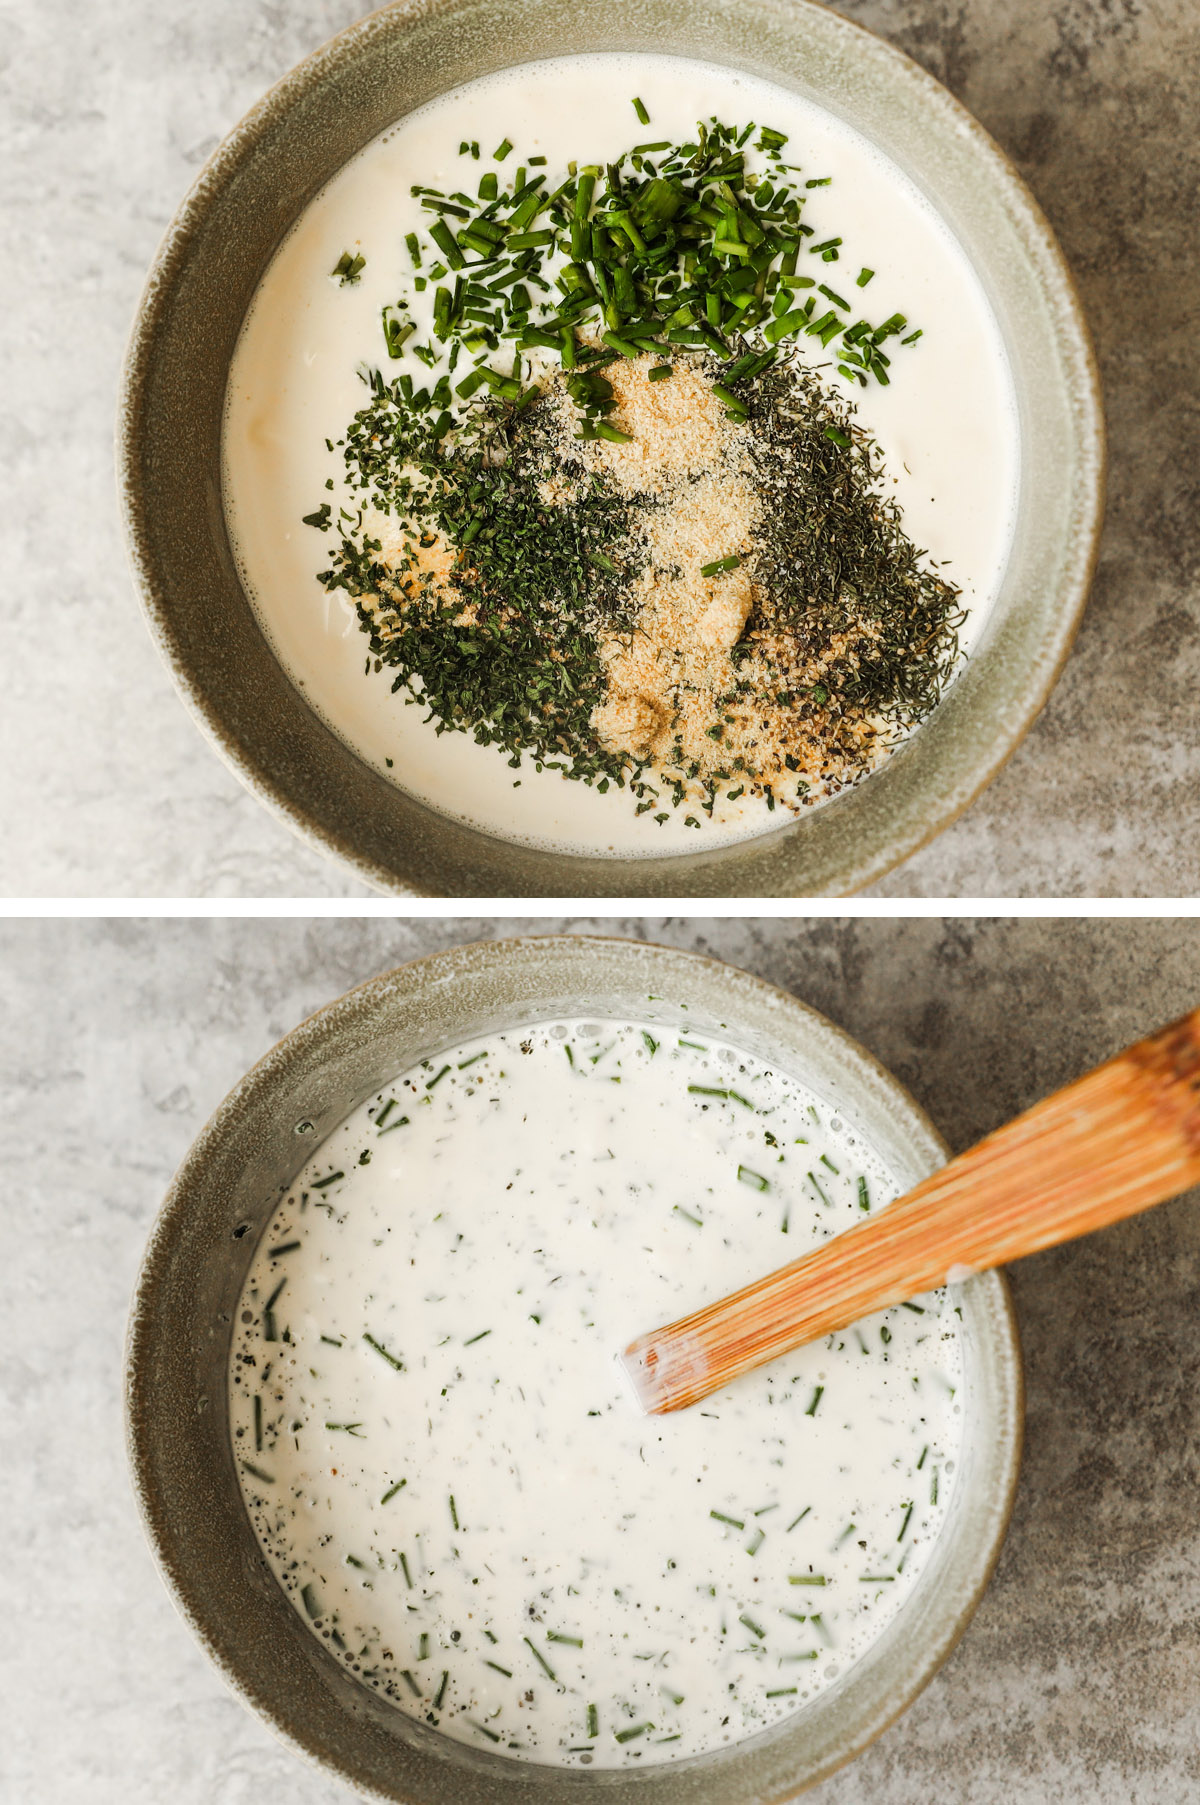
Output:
[126,937,1021,1805]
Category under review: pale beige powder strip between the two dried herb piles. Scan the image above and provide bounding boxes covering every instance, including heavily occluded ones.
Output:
[547,356,886,805]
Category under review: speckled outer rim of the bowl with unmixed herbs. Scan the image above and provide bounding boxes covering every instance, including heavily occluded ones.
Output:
[117,0,1106,897]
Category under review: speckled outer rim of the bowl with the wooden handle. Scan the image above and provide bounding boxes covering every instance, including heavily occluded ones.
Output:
[123,933,1025,1805]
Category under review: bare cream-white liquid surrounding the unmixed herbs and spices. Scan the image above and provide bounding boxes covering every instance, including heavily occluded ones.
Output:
[224,54,1018,857]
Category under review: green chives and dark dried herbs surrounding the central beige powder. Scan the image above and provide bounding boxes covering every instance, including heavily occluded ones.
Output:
[305,101,962,825]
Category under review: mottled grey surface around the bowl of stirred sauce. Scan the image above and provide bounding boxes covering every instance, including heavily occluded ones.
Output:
[0,919,1200,1805]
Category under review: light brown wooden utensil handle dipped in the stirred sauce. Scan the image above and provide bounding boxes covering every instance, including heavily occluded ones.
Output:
[624,1009,1200,1415]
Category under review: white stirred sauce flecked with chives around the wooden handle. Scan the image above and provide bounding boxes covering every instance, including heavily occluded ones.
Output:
[231,1022,964,1767]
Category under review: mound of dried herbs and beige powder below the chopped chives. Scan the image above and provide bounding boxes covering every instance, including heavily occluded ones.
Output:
[313,345,962,825]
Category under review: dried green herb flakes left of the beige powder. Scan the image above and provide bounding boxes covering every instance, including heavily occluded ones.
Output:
[321,370,639,785]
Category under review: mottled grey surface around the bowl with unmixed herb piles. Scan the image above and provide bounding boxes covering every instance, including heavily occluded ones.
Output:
[0,0,1200,895]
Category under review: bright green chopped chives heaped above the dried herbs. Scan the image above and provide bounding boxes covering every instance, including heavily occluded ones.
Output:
[371,101,920,429]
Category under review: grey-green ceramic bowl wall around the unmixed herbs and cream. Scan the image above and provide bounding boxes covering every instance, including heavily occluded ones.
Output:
[121,0,1103,897]
